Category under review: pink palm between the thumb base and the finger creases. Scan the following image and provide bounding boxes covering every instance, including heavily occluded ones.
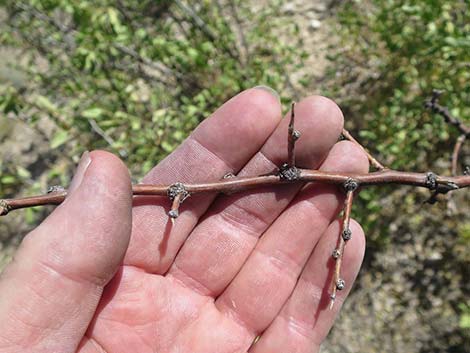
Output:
[83,267,253,353]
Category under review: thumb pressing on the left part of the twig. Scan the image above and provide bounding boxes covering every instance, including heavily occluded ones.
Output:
[0,151,132,352]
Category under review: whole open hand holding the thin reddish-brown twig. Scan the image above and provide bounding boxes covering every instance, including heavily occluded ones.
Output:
[0,87,368,353]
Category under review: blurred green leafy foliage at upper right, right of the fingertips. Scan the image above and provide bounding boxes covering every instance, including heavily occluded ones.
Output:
[328,0,470,241]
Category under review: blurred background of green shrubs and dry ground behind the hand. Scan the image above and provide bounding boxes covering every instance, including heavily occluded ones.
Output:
[0,0,470,352]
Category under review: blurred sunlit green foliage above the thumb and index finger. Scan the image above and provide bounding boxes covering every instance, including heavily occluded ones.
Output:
[0,0,299,195]
